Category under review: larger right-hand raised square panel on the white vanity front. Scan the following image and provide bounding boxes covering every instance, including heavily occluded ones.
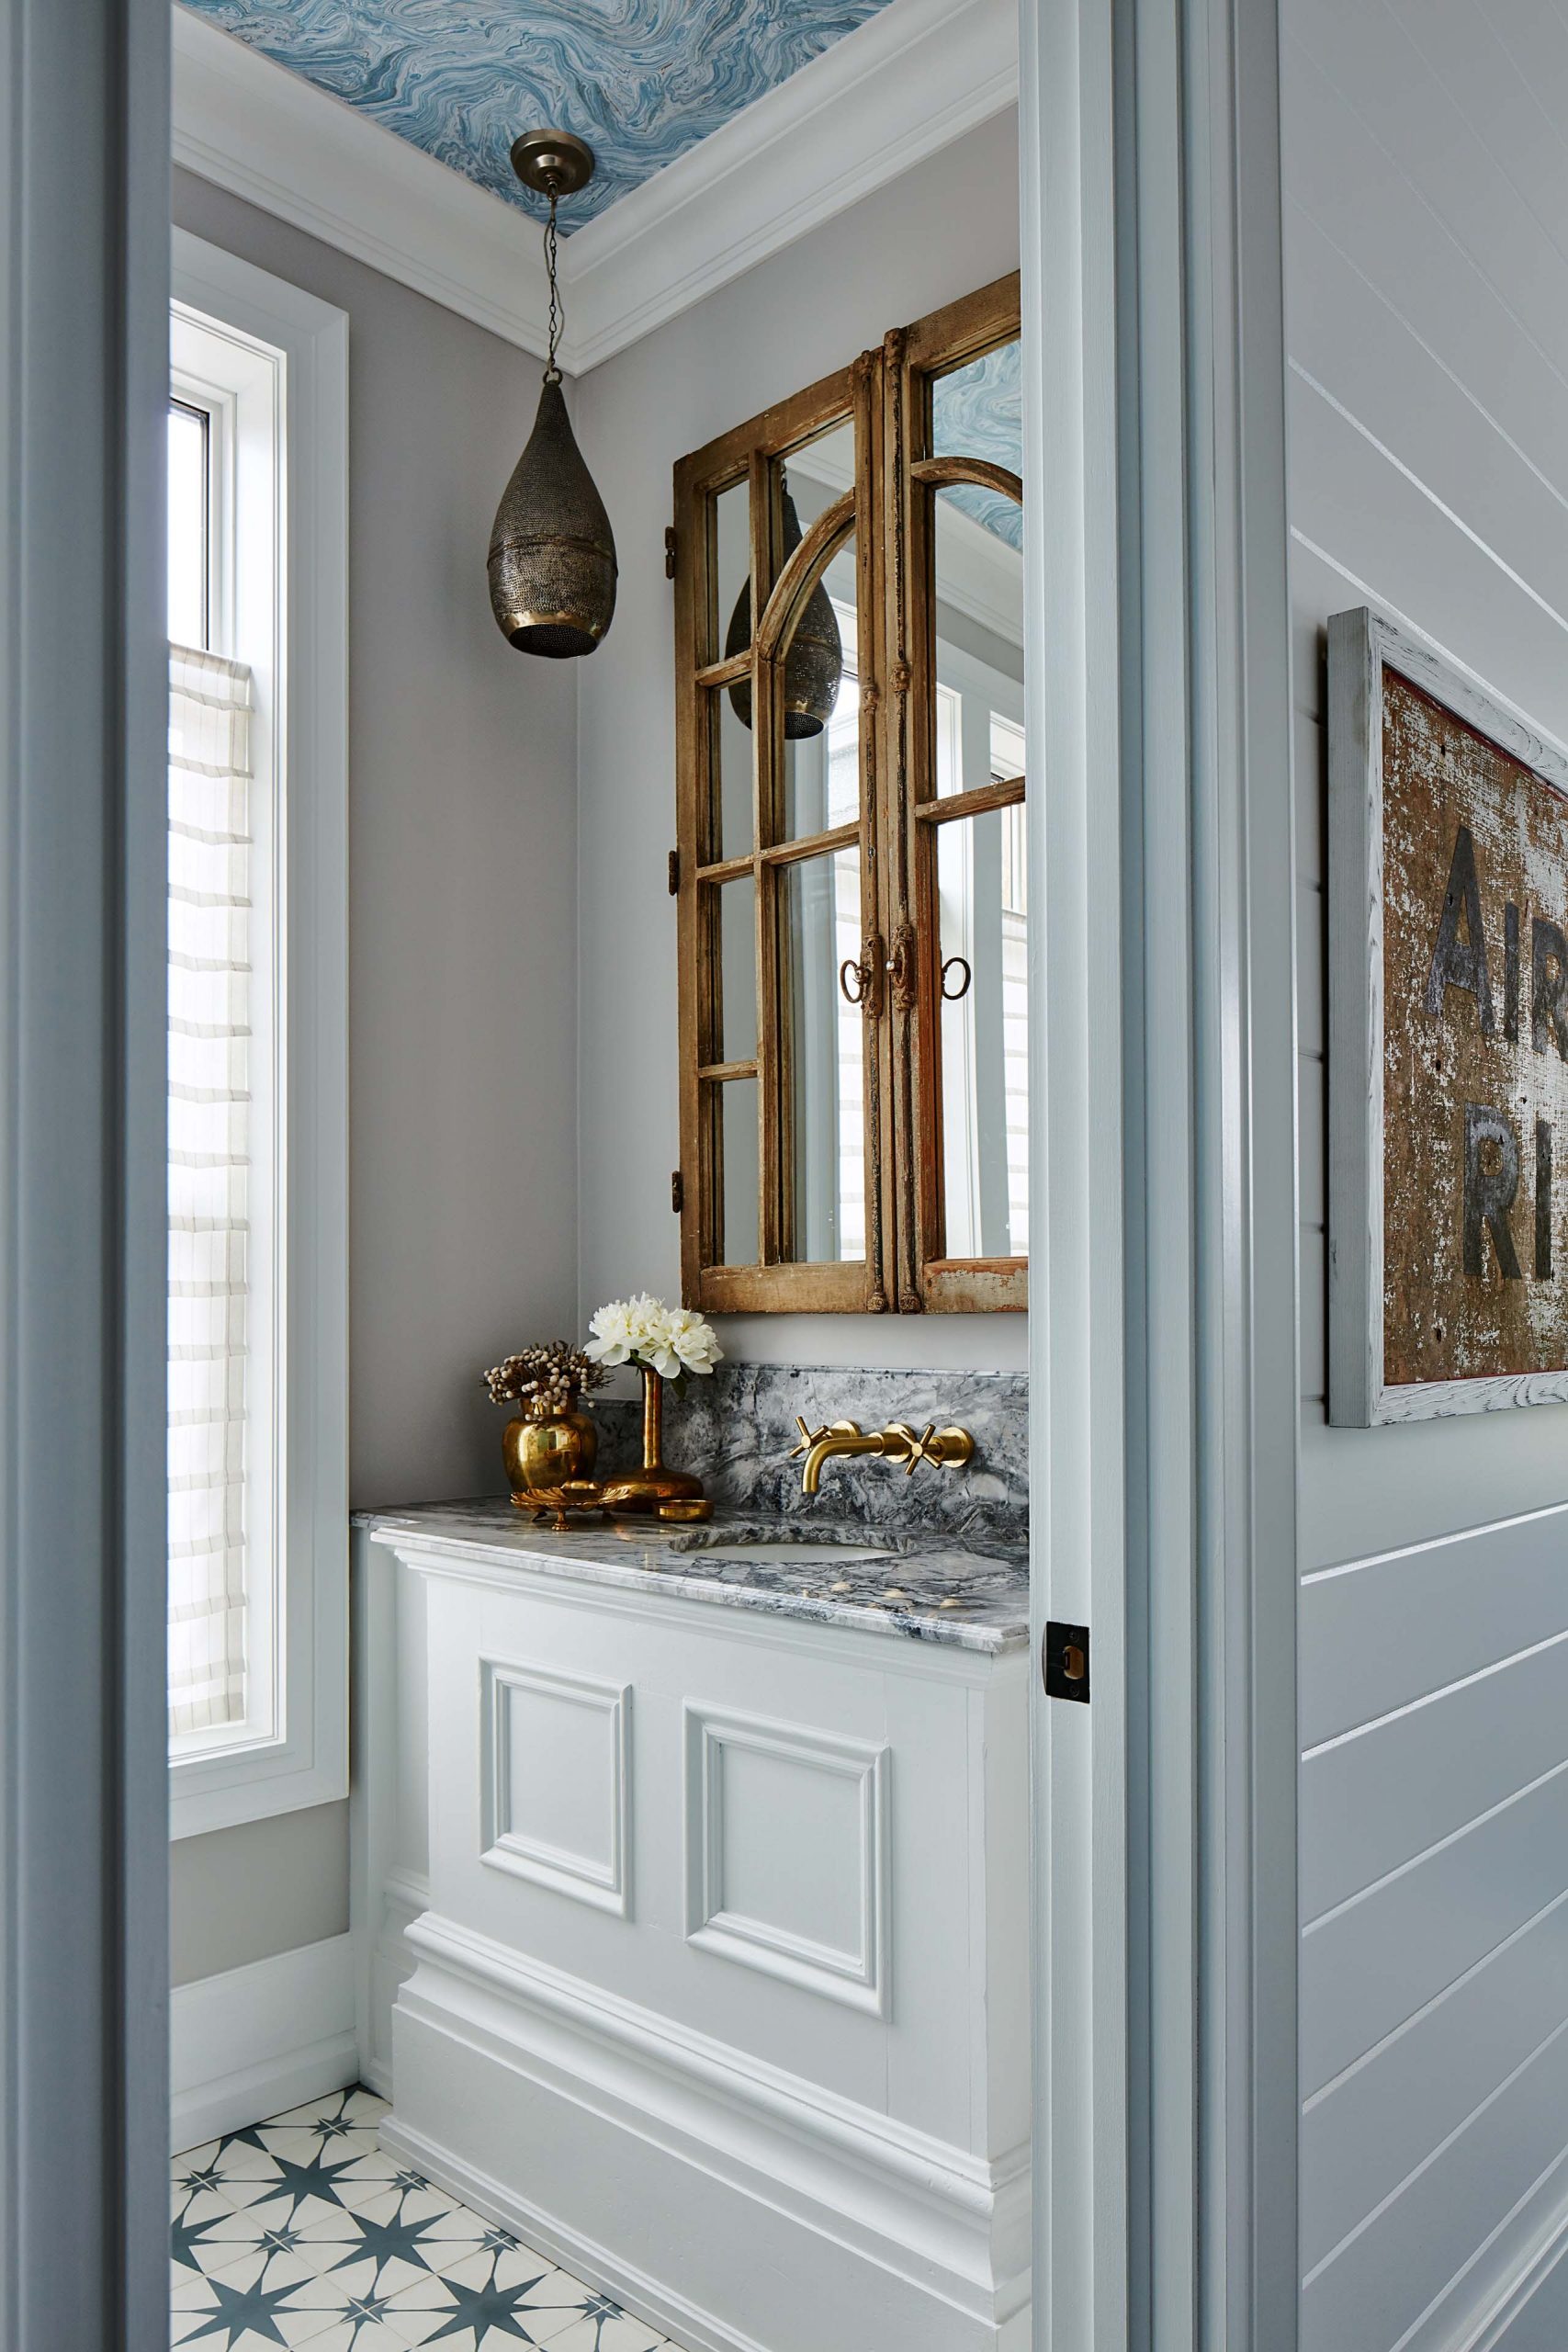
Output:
[684,1702,891,2018]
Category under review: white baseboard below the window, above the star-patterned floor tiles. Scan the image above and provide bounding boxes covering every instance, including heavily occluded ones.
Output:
[169,1936,360,2150]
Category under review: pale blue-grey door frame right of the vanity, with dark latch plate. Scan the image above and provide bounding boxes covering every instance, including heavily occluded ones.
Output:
[1021,0,1300,2352]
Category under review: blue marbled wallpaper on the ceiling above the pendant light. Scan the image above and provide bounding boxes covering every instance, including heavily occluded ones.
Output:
[175,0,886,235]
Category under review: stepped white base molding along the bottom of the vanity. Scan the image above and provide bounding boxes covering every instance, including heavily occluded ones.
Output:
[381,1912,1030,2352]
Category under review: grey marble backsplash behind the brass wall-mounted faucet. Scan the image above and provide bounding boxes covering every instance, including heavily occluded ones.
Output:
[594,1364,1030,1543]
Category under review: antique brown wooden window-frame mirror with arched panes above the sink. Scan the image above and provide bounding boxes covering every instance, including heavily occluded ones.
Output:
[672,276,1027,1312]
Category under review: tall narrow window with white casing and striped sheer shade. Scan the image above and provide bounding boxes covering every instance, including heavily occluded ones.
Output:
[167,232,348,1835]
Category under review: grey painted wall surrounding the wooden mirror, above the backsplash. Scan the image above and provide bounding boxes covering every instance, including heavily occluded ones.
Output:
[576,118,1025,1371]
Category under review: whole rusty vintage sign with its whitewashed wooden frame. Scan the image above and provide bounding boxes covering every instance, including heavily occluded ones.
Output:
[1328,609,1568,1428]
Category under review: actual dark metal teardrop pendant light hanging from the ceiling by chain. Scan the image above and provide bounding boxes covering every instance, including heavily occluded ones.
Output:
[489,131,616,661]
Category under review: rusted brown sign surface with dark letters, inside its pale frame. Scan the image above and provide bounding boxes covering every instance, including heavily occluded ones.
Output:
[1382,671,1568,1383]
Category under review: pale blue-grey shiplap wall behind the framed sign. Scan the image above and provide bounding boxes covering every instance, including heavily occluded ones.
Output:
[1283,0,1568,2352]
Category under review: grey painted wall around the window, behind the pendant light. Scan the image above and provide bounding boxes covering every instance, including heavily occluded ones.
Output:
[172,172,576,1983]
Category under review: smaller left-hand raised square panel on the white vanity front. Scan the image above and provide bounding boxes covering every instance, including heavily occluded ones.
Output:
[479,1658,632,1919]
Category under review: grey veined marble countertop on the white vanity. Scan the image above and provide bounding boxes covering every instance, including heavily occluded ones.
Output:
[355,1496,1030,1656]
